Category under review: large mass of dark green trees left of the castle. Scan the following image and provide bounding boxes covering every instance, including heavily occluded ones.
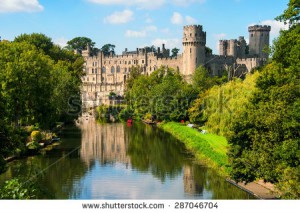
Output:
[0,33,84,165]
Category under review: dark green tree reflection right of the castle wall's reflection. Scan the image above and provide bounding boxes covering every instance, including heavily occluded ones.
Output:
[127,124,187,181]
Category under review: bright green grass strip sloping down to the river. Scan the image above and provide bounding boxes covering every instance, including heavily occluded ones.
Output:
[159,122,229,175]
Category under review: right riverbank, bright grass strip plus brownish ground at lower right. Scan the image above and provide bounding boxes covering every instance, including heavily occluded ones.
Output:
[158,122,279,199]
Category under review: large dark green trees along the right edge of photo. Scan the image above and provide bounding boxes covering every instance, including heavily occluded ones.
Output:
[228,6,300,199]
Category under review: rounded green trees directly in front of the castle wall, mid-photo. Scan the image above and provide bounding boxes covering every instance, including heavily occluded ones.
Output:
[126,67,197,121]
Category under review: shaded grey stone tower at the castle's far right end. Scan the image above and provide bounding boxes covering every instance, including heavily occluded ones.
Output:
[248,25,271,58]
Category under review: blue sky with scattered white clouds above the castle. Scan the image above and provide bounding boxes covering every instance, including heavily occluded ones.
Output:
[0,0,288,54]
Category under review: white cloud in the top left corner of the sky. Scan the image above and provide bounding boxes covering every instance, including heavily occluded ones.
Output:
[0,0,44,13]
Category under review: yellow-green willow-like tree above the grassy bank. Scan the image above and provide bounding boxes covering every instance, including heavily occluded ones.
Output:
[189,72,259,136]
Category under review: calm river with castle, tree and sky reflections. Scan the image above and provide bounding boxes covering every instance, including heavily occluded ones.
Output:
[0,120,253,199]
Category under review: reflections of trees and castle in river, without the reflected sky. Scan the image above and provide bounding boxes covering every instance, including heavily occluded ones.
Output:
[0,122,253,199]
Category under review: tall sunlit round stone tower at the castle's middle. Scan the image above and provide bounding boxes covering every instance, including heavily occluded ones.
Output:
[182,25,206,75]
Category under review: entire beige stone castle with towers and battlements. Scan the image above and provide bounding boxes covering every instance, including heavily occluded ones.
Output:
[81,25,271,109]
